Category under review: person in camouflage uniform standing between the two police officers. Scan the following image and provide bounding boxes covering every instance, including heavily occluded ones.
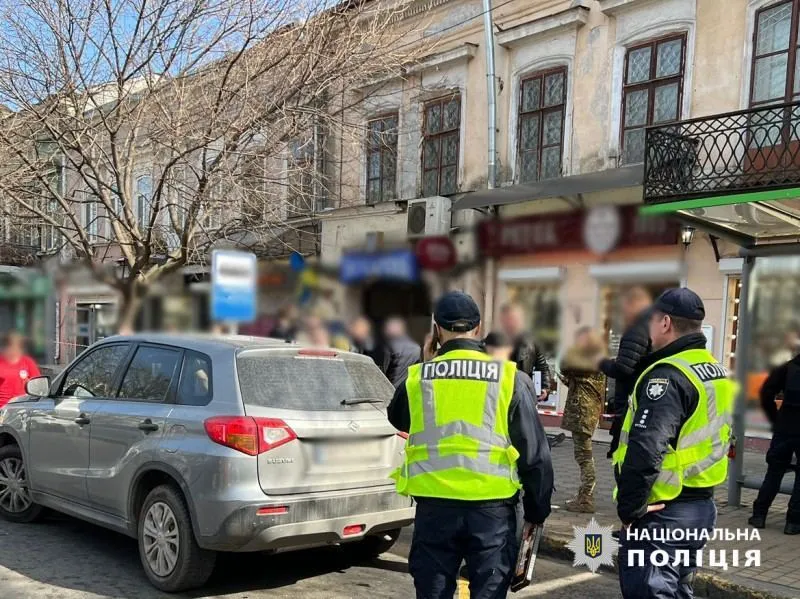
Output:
[559,327,606,514]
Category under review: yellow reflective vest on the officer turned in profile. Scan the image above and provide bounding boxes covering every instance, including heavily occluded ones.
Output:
[613,349,738,504]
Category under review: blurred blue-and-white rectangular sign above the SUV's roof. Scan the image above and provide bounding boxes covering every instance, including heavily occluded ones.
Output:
[211,250,258,322]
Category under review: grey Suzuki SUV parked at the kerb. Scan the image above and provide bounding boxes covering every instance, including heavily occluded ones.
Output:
[0,334,414,591]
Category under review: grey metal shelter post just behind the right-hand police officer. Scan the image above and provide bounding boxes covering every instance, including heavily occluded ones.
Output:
[728,255,755,507]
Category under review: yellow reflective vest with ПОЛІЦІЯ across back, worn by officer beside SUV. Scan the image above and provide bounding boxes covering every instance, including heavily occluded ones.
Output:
[393,350,520,501]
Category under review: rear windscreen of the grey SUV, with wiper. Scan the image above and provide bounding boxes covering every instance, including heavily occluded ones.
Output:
[236,354,394,410]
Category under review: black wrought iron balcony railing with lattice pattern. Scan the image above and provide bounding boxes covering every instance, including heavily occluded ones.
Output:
[644,102,800,204]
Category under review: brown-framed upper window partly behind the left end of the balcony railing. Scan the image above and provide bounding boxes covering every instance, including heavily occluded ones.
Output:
[620,33,687,164]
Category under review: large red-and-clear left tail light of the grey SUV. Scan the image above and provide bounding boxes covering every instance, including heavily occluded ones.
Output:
[204,416,297,455]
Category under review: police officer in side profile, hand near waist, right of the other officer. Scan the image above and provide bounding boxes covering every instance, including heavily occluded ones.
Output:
[613,289,736,599]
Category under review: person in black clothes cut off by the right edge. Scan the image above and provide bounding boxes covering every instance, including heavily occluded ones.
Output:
[748,354,800,535]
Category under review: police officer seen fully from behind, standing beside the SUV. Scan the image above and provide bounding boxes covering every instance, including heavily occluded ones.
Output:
[389,292,553,599]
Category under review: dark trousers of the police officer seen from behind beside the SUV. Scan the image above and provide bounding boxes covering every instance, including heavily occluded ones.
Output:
[408,500,518,599]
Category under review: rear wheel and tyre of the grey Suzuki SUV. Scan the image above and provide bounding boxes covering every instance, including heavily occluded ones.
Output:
[136,485,216,593]
